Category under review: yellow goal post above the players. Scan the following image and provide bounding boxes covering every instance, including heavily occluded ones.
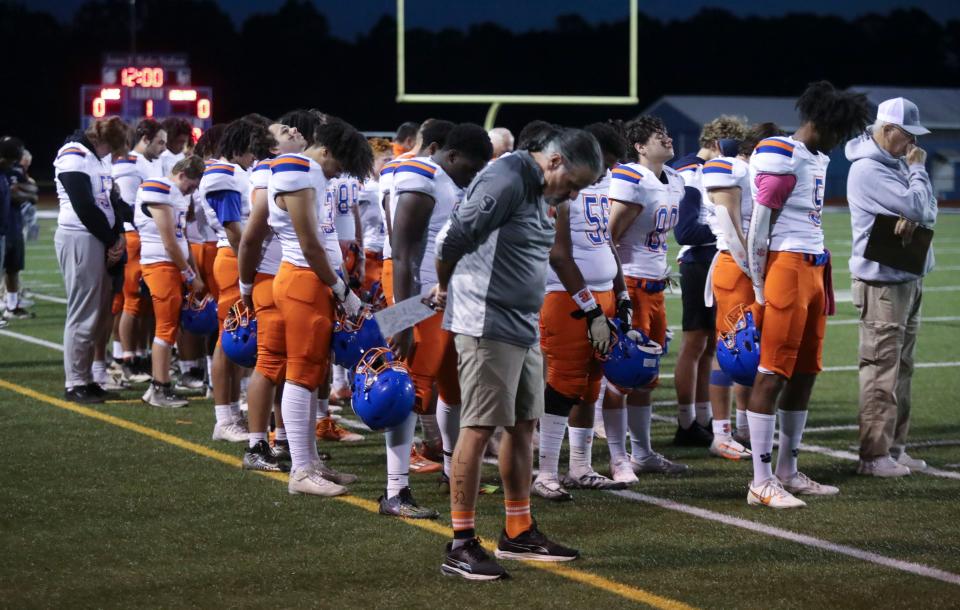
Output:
[397,0,639,129]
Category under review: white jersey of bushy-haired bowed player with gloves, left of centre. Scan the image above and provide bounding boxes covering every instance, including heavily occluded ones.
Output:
[267,154,343,270]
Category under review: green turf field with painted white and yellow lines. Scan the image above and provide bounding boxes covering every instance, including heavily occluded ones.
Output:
[0,214,960,608]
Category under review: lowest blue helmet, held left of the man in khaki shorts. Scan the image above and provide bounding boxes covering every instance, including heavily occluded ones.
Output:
[352,347,416,430]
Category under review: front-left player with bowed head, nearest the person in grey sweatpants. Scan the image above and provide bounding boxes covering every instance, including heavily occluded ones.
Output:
[134,156,204,408]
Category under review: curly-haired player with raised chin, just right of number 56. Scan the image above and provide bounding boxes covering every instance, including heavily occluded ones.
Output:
[603,115,687,483]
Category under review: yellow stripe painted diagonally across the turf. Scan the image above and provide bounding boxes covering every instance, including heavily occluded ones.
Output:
[0,379,693,610]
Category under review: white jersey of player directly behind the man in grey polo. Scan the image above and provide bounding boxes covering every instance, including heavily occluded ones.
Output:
[390,157,463,295]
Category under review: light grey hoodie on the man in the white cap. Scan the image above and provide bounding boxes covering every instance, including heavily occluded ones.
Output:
[845,132,937,282]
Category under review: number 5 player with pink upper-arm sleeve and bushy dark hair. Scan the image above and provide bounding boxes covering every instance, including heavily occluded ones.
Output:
[747,81,869,508]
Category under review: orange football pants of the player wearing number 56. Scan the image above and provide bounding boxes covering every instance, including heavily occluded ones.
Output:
[540,290,617,402]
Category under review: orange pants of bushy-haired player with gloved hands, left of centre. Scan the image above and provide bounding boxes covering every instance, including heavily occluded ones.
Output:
[274,262,334,391]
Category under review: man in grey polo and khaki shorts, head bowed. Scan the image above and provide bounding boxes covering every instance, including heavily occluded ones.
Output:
[434,128,609,580]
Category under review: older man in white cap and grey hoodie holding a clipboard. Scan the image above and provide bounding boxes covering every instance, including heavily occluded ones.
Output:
[846,97,937,477]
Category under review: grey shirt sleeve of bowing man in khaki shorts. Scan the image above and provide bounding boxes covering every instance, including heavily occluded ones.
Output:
[436,170,523,263]
